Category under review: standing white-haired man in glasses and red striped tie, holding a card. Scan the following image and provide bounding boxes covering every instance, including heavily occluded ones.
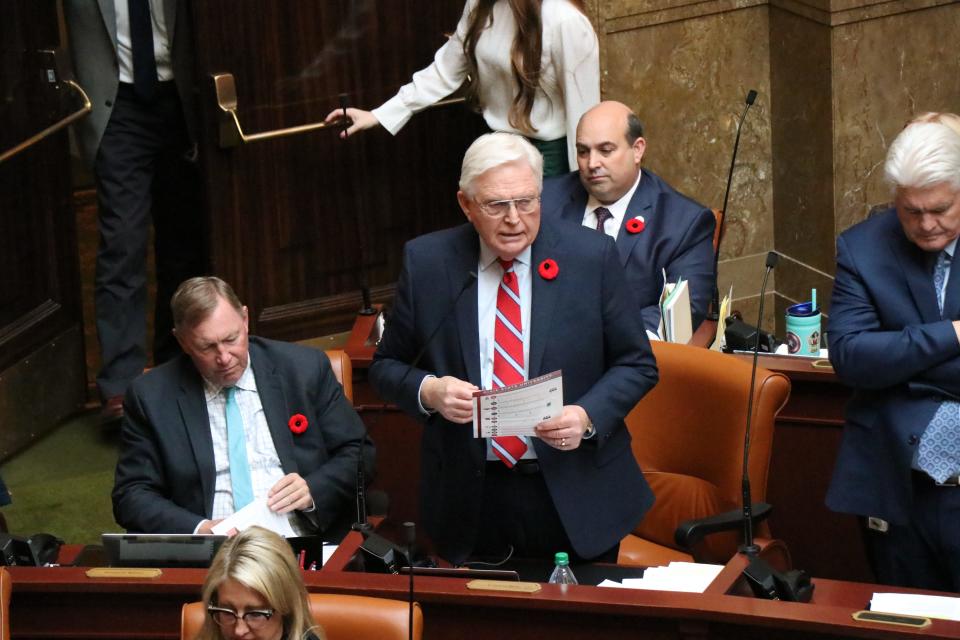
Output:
[370,133,657,563]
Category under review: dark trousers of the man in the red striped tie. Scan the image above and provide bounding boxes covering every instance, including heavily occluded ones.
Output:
[472,462,620,563]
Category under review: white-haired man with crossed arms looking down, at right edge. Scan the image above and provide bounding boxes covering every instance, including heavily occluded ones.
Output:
[827,117,960,591]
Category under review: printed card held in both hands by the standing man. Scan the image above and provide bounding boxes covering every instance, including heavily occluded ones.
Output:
[473,370,563,438]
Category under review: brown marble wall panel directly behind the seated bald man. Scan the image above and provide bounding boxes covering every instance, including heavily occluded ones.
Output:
[598,5,773,258]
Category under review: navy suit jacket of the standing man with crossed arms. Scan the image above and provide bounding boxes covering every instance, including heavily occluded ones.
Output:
[827,209,960,524]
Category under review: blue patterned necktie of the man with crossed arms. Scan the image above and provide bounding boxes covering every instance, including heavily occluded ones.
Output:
[917,251,960,482]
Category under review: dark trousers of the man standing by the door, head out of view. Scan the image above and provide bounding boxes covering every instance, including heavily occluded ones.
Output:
[94,82,206,398]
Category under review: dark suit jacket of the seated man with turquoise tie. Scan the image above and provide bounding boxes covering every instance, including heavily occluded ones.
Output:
[113,336,373,533]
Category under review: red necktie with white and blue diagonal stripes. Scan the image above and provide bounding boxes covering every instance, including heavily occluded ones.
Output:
[491,260,527,467]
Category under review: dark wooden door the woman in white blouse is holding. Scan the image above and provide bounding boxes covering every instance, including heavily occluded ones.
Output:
[193,0,484,339]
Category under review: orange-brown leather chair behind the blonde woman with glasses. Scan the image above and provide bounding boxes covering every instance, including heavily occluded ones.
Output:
[180,593,423,640]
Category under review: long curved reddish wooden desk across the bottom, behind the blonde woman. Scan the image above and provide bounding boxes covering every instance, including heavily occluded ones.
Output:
[10,534,960,640]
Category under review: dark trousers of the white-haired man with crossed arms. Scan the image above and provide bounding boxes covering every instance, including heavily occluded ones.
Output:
[861,472,960,592]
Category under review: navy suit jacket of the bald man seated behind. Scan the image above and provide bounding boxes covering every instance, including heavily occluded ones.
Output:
[542,169,716,332]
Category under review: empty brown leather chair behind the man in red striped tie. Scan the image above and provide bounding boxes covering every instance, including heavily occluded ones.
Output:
[618,342,790,566]
